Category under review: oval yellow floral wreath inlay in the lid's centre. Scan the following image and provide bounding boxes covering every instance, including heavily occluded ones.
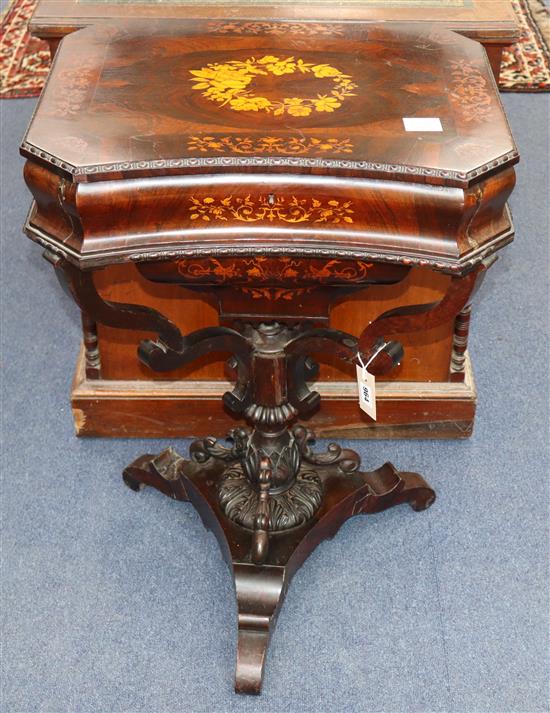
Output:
[190,55,357,117]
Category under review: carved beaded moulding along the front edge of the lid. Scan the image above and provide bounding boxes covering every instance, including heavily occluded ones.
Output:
[21,141,519,186]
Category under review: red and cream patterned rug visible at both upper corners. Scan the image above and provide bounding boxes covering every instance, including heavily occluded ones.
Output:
[0,0,550,99]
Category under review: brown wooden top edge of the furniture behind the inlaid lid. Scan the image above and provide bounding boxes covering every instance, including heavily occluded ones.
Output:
[31,0,519,79]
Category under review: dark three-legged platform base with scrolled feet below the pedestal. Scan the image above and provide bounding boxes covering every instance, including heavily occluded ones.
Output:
[123,440,435,694]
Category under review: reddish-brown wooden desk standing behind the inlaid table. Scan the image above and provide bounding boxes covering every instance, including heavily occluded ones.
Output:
[31,9,517,438]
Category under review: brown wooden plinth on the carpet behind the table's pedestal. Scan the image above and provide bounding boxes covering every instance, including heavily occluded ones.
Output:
[71,352,476,439]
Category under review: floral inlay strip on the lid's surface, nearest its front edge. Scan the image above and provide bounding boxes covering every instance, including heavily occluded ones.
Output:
[187,136,353,156]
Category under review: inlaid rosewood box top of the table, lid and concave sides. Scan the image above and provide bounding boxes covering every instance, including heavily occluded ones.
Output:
[22,22,518,271]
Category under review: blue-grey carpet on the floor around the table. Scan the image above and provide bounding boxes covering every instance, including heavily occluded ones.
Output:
[0,94,549,713]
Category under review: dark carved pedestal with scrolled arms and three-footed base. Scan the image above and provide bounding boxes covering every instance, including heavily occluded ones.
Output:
[46,238,485,693]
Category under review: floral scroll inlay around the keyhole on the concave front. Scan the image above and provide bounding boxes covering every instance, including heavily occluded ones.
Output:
[189,195,353,224]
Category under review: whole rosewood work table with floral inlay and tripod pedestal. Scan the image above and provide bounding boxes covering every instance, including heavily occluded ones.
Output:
[21,22,518,693]
